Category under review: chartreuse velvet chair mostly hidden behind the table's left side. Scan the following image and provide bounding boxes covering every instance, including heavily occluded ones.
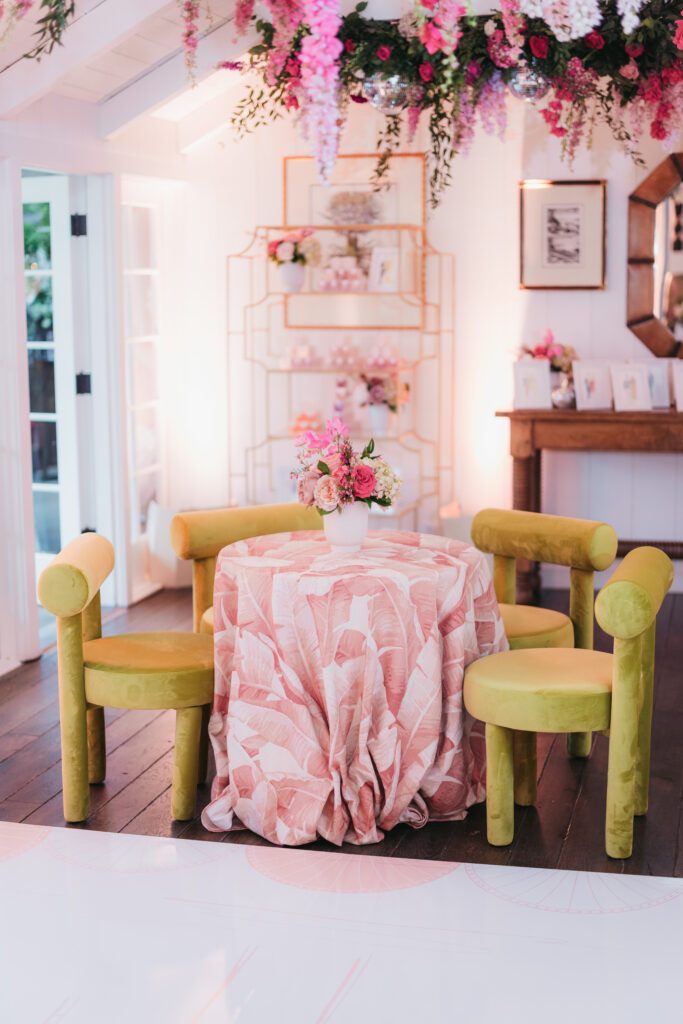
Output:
[171,502,323,634]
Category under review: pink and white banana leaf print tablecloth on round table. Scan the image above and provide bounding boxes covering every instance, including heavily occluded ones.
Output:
[203,530,507,846]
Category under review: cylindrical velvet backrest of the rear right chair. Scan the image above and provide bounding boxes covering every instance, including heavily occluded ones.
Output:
[472,509,617,571]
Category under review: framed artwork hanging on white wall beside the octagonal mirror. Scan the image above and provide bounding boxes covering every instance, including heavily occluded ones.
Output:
[519,178,607,291]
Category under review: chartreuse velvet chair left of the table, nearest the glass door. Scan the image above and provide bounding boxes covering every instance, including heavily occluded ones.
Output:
[38,534,213,821]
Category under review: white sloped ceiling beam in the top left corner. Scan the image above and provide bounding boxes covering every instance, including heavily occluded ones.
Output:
[0,0,168,118]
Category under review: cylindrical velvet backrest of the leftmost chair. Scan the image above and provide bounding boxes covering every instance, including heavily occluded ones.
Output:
[38,534,114,618]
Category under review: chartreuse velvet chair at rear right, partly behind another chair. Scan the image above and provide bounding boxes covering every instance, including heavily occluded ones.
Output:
[472,509,616,774]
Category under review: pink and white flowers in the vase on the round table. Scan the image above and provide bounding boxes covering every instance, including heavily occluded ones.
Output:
[292,417,400,515]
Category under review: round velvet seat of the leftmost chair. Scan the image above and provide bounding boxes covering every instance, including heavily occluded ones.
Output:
[83,632,213,709]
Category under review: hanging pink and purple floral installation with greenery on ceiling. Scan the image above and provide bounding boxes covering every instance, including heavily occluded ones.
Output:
[7,0,683,206]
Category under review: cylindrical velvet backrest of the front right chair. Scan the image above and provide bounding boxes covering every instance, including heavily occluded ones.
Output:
[595,547,674,640]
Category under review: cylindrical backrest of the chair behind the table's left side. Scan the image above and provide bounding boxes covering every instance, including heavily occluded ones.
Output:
[171,502,323,559]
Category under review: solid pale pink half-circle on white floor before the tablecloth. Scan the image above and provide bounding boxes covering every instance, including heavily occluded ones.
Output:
[247,846,460,893]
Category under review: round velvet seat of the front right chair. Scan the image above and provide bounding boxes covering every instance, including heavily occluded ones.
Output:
[463,647,612,732]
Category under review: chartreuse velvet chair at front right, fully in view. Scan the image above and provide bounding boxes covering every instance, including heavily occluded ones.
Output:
[464,547,674,857]
